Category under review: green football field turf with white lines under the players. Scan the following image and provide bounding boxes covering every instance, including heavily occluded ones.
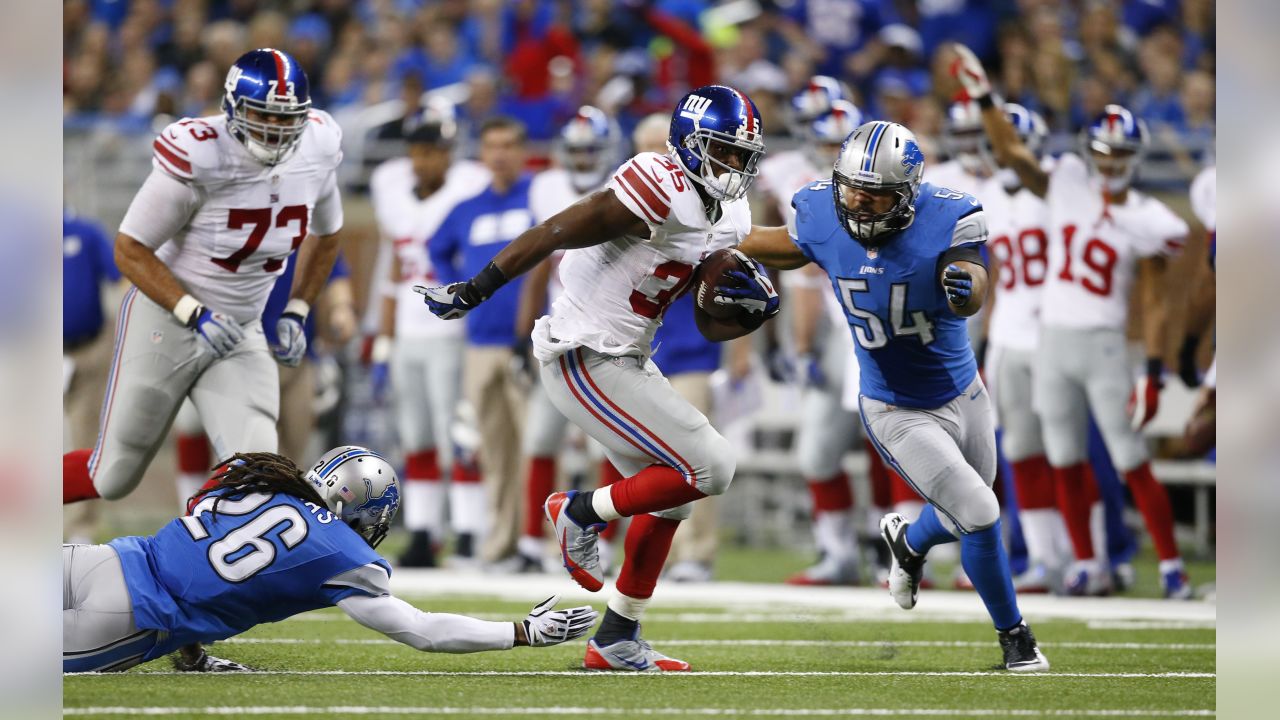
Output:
[63,543,1217,717]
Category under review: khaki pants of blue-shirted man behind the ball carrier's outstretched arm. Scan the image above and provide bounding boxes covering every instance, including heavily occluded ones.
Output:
[462,346,525,562]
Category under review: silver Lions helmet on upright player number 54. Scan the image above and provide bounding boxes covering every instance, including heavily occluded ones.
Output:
[831,120,924,245]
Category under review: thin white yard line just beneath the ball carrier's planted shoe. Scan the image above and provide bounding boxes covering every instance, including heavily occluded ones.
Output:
[63,670,1217,680]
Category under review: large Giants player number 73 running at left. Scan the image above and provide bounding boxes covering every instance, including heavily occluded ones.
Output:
[63,49,343,502]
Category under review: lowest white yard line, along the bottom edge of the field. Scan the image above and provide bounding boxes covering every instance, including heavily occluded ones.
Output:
[63,705,1216,717]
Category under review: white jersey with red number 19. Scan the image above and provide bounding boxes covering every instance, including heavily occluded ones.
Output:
[1042,154,1188,331]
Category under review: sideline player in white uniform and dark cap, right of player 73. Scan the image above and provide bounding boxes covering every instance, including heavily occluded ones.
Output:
[369,100,490,568]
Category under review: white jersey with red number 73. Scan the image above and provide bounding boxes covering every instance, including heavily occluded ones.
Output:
[120,110,343,323]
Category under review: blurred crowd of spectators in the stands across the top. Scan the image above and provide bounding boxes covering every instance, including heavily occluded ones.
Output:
[63,0,1216,154]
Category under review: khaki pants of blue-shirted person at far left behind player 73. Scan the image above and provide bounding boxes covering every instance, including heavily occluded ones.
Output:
[63,325,111,538]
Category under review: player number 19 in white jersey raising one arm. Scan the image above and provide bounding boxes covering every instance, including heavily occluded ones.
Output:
[951,45,1192,598]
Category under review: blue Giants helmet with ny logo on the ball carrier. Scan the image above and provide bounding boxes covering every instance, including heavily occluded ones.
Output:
[667,85,764,200]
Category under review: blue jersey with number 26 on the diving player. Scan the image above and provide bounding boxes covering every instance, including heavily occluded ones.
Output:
[110,491,390,660]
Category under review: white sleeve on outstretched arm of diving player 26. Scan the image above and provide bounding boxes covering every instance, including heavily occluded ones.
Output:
[338,594,516,652]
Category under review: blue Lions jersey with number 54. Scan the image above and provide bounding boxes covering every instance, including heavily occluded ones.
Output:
[791,181,987,409]
